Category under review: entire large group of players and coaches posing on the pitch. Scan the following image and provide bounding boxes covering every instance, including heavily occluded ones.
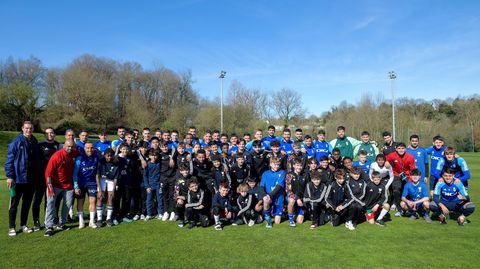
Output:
[5,121,475,236]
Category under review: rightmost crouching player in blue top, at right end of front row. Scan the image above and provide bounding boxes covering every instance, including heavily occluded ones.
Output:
[430,169,475,226]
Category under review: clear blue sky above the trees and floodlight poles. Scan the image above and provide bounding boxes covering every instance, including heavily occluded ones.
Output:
[0,0,480,114]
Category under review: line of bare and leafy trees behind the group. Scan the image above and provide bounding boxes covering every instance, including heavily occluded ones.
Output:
[0,54,480,151]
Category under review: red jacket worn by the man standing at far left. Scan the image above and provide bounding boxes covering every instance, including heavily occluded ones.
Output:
[45,149,78,190]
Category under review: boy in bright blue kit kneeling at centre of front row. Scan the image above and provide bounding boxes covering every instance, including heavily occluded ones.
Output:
[260,157,285,228]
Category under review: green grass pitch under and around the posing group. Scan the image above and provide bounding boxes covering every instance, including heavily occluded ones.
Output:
[0,132,480,268]
